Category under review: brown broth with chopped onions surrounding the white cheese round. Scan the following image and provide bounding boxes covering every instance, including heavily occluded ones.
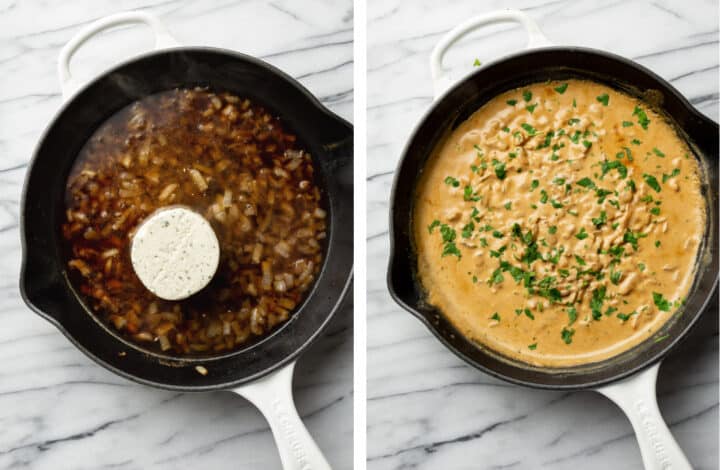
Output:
[62,89,326,355]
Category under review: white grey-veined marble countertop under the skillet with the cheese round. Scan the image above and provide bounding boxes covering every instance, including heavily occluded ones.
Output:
[0,0,353,470]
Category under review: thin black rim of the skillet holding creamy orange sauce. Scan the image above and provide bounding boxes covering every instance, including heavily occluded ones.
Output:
[386,46,720,391]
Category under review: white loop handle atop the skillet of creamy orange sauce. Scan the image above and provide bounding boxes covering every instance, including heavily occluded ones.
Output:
[430,10,552,98]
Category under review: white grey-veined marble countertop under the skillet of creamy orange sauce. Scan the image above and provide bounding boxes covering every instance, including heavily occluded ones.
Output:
[367,0,719,470]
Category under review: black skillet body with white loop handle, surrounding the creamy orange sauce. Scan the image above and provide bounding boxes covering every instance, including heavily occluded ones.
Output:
[388,11,718,470]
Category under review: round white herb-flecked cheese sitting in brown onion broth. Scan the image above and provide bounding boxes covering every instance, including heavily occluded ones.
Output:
[130,206,220,300]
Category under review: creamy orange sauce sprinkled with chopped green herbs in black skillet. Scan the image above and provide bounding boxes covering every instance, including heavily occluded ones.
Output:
[413,80,705,367]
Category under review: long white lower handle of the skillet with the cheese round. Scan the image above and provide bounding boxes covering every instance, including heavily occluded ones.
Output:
[233,362,331,470]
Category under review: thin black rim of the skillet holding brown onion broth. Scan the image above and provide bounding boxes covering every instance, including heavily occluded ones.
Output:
[18,46,354,392]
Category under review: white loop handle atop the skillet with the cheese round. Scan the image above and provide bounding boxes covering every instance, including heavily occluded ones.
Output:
[58,11,179,100]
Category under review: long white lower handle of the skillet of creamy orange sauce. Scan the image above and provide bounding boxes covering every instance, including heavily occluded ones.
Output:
[596,364,692,470]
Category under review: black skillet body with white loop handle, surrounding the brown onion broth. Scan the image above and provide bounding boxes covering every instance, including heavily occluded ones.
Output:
[20,12,353,468]
